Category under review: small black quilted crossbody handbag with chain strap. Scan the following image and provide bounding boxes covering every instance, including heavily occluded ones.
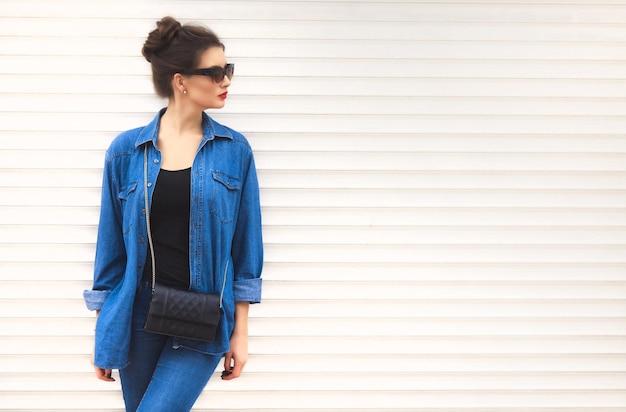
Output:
[144,144,226,342]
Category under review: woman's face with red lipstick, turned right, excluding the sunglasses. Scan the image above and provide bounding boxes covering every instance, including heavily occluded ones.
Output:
[184,47,231,110]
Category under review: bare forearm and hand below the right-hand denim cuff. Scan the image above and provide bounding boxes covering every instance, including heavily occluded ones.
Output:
[222,302,250,381]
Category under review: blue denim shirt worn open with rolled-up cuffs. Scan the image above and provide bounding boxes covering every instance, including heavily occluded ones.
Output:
[83,109,263,369]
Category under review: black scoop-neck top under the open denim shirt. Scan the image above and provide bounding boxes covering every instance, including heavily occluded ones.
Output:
[143,168,191,290]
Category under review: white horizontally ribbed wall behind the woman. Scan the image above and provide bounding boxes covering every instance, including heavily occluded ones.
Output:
[0,0,626,412]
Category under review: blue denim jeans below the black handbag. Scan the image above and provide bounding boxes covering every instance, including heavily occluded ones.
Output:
[120,282,223,412]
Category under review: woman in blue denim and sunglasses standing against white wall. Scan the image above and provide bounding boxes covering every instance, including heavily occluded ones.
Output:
[84,17,263,412]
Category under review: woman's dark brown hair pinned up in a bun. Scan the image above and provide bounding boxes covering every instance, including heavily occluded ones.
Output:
[141,16,224,97]
